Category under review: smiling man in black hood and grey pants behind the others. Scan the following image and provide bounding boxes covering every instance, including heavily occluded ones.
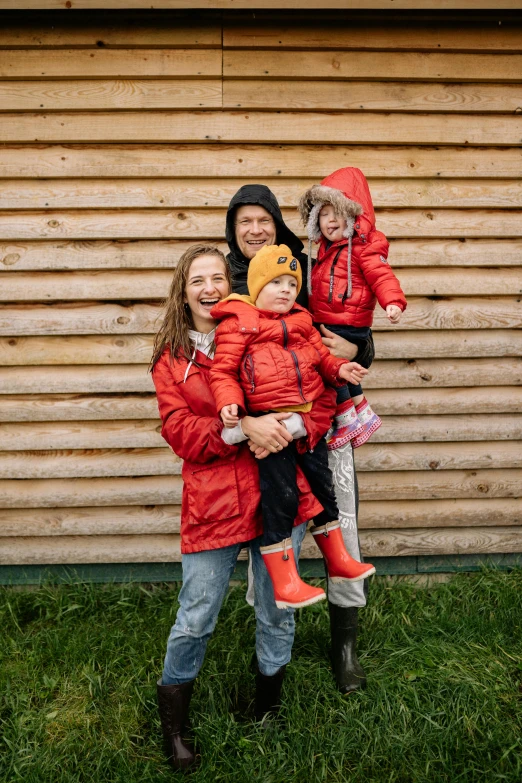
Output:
[226,185,374,694]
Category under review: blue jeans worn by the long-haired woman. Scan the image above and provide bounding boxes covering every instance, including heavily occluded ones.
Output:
[162,525,306,685]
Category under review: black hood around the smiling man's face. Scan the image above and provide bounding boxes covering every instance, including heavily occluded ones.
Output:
[225,185,306,301]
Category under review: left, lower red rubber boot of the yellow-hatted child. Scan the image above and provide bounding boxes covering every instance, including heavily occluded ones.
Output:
[259,538,326,609]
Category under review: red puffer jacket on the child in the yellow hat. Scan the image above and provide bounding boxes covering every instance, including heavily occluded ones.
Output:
[210,294,346,448]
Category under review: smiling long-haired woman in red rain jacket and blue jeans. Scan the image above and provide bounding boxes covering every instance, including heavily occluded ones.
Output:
[151,245,321,768]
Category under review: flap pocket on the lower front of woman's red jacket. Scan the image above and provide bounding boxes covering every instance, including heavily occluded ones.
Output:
[183,462,240,525]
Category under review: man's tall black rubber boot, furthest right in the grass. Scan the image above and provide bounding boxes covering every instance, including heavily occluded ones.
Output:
[328,602,366,695]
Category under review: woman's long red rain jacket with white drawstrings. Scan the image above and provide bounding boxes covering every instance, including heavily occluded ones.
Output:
[152,348,322,554]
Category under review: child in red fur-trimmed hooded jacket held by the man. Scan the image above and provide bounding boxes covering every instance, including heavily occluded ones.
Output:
[299,167,406,450]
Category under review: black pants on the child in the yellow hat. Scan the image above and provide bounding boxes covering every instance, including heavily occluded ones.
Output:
[259,438,339,546]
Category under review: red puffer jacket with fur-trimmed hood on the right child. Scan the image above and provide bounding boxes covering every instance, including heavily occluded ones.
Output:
[300,167,406,326]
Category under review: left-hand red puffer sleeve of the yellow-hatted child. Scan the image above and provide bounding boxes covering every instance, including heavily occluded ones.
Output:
[210,318,246,412]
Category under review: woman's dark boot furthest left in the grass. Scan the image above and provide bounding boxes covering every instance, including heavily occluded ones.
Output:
[157,680,196,769]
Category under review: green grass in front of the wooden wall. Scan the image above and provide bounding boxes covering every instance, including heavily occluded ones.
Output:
[0,571,522,783]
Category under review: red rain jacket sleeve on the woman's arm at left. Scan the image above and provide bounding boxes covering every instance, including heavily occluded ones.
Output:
[152,355,237,462]
